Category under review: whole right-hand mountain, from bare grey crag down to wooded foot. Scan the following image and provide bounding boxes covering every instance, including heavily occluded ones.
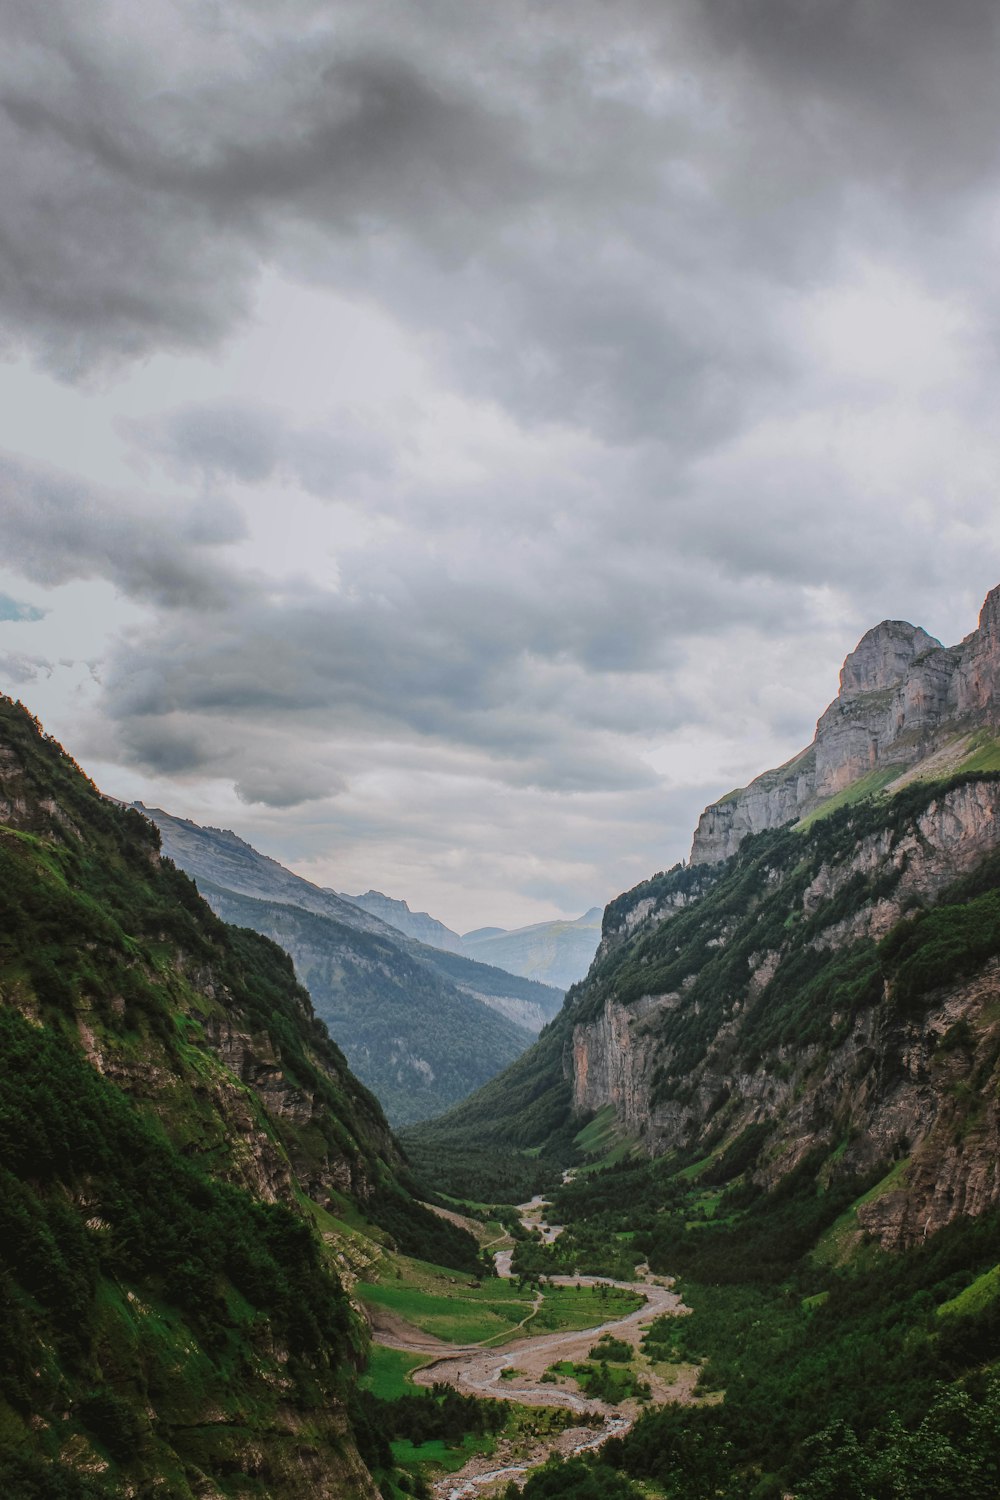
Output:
[412,590,1000,1253]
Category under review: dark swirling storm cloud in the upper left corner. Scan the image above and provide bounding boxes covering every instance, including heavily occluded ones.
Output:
[0,0,542,375]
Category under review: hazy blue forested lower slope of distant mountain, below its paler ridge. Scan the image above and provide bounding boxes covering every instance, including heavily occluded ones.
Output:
[201,884,532,1125]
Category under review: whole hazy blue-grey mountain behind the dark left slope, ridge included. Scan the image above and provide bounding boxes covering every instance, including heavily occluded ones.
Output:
[141,809,562,1125]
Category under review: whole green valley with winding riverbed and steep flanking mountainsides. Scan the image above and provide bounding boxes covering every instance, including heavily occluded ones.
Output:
[0,593,1000,1500]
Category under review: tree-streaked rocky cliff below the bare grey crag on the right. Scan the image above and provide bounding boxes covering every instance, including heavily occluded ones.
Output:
[565,777,1000,1245]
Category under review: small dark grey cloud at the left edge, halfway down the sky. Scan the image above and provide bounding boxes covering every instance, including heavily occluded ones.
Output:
[0,453,243,609]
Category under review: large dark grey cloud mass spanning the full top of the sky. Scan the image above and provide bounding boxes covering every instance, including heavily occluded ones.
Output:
[0,0,997,438]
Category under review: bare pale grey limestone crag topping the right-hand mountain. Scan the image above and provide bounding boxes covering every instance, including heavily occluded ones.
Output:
[691,588,1000,864]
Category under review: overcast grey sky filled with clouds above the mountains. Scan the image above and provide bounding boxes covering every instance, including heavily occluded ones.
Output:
[0,0,1000,932]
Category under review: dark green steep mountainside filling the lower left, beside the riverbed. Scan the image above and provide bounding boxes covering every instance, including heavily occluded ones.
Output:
[0,699,475,1500]
